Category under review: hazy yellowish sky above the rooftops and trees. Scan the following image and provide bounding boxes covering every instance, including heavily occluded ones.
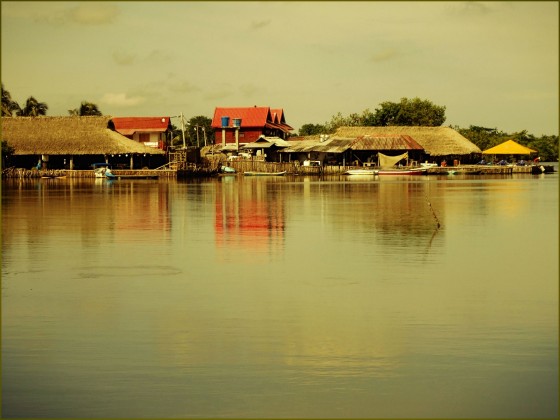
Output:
[0,1,559,136]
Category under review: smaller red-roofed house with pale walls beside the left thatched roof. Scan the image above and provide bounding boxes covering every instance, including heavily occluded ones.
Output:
[109,117,171,149]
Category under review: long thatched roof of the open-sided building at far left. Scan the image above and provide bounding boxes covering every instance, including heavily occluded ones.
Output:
[2,116,165,155]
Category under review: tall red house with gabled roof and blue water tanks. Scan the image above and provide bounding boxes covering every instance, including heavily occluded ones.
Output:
[212,106,293,144]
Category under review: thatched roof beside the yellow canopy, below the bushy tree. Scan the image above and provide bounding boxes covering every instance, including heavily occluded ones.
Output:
[333,126,482,156]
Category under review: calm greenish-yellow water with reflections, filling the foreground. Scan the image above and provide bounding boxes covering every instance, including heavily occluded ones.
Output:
[2,173,559,418]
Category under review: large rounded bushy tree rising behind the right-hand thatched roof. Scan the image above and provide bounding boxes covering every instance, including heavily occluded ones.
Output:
[371,98,445,127]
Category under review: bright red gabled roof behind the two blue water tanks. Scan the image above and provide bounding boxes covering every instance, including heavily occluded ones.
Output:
[212,106,293,132]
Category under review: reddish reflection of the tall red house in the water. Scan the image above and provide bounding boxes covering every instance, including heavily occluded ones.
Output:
[215,178,285,252]
